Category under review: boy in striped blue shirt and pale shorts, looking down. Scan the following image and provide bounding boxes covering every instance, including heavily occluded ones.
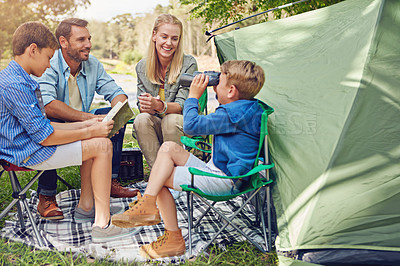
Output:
[0,22,138,242]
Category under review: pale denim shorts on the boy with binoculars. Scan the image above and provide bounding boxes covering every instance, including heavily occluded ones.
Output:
[174,154,239,196]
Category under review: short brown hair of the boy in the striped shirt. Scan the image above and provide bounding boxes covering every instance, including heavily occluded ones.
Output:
[12,21,58,56]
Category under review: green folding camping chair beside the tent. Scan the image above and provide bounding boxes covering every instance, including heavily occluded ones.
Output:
[181,101,274,255]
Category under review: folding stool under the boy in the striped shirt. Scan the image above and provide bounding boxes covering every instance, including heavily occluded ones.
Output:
[0,160,44,247]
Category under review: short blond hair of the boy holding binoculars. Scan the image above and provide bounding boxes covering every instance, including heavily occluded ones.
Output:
[221,60,265,100]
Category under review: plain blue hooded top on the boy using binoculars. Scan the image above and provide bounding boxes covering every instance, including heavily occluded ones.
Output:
[183,98,263,176]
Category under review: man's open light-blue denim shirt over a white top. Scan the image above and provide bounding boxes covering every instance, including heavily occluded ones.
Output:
[37,49,126,112]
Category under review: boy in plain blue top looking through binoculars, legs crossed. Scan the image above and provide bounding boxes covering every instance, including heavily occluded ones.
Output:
[112,60,265,258]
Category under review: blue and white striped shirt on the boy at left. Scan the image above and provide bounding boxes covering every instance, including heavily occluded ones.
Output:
[0,60,56,167]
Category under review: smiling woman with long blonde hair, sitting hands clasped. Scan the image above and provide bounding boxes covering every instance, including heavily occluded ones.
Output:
[134,14,197,169]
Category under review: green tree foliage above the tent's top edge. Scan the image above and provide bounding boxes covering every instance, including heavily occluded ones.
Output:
[180,0,344,29]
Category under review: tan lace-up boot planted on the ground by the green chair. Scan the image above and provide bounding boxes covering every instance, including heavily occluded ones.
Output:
[139,229,186,259]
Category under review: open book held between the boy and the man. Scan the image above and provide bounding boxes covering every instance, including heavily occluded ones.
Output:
[103,99,133,138]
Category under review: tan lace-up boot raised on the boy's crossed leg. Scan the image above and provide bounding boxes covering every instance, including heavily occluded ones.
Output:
[111,192,161,228]
